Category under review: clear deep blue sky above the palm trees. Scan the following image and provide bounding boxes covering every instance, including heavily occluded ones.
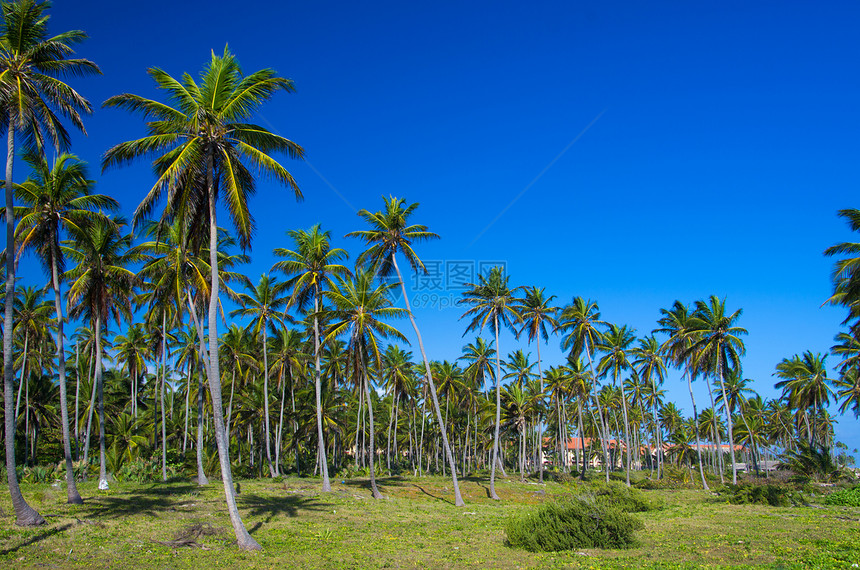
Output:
[16,0,860,458]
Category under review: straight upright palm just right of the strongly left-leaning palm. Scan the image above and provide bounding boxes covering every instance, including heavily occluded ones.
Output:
[460,266,522,500]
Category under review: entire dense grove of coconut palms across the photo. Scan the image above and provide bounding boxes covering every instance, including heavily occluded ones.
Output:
[0,0,860,548]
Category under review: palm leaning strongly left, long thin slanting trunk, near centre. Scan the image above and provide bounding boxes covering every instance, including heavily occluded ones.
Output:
[347,196,466,507]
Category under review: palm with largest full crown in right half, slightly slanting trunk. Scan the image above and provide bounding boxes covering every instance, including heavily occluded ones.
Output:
[689,295,747,485]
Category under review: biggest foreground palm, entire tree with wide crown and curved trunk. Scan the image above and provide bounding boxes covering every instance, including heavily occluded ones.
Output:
[103,48,304,550]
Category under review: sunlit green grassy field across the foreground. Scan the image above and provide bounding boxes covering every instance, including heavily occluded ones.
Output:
[0,470,860,570]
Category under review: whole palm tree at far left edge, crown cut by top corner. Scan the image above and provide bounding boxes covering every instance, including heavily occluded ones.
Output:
[0,0,100,525]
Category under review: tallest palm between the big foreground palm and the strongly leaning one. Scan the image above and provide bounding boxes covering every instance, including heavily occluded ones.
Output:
[272,224,350,493]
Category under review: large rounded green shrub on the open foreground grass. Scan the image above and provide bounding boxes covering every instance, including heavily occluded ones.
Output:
[505,497,643,552]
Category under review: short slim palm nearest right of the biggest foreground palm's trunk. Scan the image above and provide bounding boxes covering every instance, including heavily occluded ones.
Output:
[230,273,287,477]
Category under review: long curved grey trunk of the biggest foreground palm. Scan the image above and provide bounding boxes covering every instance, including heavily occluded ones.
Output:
[206,175,262,550]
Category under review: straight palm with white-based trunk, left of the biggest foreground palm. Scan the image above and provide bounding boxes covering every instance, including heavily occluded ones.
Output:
[62,218,139,489]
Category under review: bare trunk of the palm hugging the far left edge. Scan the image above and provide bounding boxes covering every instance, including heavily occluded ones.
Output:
[3,122,45,526]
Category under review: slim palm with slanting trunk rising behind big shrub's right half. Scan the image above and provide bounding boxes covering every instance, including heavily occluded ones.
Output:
[558,297,609,483]
